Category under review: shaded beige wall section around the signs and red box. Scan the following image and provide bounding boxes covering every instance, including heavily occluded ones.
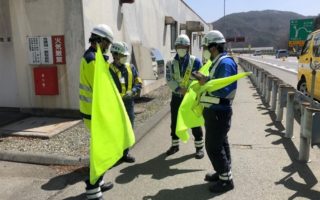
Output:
[10,0,84,109]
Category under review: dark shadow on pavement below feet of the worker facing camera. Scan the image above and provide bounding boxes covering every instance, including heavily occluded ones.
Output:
[116,154,202,184]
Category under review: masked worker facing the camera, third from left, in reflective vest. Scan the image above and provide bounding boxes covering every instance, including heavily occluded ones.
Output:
[166,34,204,159]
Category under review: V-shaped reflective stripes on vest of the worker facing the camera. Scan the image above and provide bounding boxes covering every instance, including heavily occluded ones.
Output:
[172,55,196,88]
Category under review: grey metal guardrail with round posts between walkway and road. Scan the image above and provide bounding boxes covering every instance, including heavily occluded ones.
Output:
[238,57,320,162]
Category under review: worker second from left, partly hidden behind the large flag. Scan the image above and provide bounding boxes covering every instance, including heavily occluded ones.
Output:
[110,42,142,163]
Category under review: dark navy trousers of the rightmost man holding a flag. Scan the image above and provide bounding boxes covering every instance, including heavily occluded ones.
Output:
[203,108,232,174]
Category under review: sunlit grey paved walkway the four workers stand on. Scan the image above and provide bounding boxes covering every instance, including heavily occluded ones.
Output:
[0,69,320,200]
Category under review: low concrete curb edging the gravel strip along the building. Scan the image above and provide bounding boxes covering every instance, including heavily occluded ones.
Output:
[0,105,170,165]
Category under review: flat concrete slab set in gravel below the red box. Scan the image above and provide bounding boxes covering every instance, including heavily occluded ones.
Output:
[0,117,80,138]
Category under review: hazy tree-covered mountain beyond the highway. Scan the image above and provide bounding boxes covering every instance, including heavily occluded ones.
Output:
[212,10,314,49]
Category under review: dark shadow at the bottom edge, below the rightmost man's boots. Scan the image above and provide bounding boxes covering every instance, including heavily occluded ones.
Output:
[143,183,218,200]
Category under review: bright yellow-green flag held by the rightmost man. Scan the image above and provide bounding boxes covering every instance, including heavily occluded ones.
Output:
[176,62,251,142]
